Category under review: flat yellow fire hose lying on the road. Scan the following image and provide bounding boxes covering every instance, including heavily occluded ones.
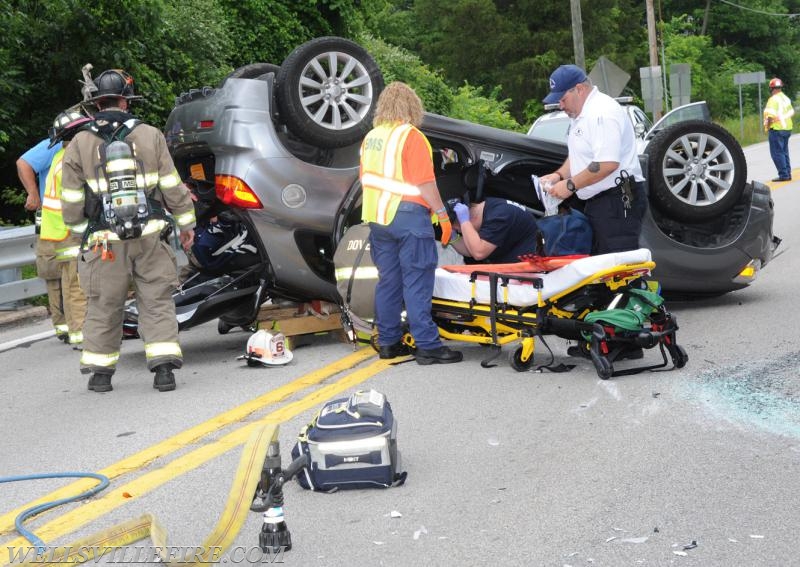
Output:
[9,423,278,566]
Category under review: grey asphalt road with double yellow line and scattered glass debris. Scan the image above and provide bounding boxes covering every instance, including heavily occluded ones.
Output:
[0,136,800,567]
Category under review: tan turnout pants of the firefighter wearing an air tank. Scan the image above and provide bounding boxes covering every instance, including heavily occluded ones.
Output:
[78,234,183,374]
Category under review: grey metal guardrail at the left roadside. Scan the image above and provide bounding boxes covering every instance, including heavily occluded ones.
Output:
[0,225,47,309]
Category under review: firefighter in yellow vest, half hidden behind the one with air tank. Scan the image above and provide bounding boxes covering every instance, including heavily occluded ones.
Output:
[37,110,91,350]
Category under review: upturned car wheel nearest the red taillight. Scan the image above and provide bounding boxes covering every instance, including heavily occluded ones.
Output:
[277,37,383,148]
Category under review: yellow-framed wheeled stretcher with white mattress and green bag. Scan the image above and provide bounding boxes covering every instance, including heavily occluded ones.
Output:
[424,248,688,379]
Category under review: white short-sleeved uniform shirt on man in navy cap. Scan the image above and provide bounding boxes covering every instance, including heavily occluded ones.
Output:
[567,87,644,199]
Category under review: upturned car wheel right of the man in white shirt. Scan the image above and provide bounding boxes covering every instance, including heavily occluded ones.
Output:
[647,120,747,222]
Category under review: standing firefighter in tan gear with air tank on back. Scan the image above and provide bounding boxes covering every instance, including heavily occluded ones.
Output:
[61,69,195,392]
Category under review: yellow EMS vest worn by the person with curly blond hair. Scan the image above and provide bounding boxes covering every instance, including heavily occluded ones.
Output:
[361,124,433,225]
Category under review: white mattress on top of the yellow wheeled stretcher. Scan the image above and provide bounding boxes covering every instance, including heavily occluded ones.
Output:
[433,248,651,307]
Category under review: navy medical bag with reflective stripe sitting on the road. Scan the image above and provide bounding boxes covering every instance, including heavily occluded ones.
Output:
[292,390,406,492]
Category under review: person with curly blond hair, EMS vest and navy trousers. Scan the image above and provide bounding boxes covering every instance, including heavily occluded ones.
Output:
[360,82,463,364]
